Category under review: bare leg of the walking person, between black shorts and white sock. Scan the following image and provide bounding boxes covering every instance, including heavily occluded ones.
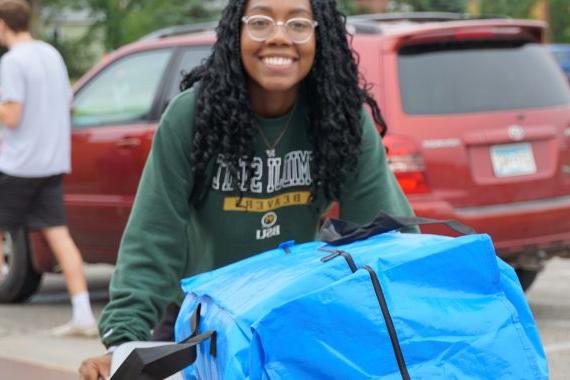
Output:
[42,226,87,296]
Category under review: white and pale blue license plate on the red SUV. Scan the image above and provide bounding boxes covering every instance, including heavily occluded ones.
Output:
[491,143,536,177]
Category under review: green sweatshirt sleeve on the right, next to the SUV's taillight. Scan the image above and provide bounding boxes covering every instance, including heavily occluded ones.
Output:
[339,108,419,232]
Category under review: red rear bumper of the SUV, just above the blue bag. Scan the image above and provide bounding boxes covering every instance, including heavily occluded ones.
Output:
[410,196,570,259]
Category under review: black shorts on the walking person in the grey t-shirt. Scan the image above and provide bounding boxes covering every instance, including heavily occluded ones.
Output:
[0,172,65,230]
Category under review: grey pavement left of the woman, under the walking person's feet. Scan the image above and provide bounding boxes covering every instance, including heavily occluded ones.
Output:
[0,265,112,380]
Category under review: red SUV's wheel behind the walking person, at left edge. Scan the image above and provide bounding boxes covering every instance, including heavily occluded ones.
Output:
[0,228,42,303]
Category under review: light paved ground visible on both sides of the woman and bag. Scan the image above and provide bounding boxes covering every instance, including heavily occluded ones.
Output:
[0,259,570,380]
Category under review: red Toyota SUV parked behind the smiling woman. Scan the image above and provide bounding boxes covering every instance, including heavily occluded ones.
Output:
[0,14,570,302]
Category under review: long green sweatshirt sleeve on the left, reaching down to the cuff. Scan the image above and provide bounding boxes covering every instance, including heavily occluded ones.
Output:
[99,92,194,347]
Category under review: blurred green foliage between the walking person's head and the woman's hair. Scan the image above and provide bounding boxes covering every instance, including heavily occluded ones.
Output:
[29,0,219,79]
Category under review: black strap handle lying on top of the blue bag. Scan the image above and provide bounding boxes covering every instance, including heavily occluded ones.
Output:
[319,211,476,245]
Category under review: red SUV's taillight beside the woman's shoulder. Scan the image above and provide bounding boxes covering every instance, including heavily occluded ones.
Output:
[383,135,430,194]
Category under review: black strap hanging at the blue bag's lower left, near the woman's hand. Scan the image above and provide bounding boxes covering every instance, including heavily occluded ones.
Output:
[111,304,216,380]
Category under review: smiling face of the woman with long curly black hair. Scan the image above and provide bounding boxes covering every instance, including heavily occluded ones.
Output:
[241,0,316,101]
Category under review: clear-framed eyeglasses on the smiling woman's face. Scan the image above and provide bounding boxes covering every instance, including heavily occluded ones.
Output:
[241,15,319,44]
